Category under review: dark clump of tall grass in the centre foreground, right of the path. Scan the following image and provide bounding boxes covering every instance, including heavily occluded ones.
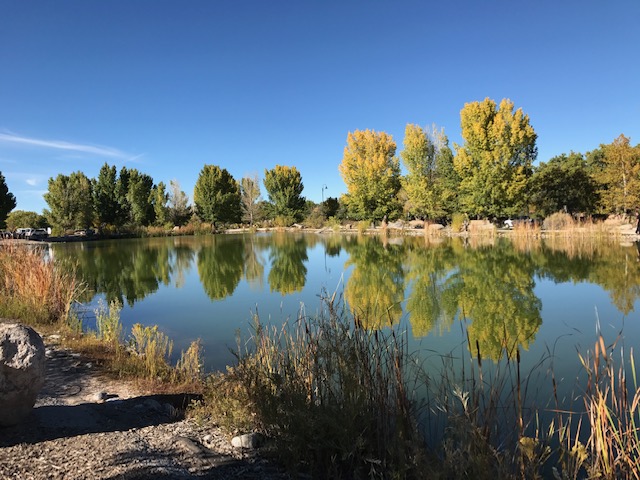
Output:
[200,298,426,478]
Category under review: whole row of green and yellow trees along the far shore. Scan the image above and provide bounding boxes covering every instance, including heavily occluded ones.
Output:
[0,98,640,231]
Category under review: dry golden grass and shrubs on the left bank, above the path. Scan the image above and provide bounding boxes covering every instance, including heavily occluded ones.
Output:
[0,243,202,392]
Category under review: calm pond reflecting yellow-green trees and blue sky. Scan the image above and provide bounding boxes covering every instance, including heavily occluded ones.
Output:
[51,232,640,386]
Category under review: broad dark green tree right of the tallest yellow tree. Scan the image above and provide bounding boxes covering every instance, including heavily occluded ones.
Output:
[530,152,598,217]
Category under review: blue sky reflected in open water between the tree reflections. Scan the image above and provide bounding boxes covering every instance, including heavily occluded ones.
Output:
[55,236,640,382]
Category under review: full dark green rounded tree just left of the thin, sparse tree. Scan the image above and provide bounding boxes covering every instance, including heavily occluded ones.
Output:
[193,165,241,228]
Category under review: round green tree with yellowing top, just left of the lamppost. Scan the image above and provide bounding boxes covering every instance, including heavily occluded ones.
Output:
[264,165,305,221]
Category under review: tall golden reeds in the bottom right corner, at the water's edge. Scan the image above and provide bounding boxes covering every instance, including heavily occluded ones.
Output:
[549,334,640,480]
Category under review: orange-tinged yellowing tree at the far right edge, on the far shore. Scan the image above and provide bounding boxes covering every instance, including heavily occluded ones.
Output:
[595,135,640,213]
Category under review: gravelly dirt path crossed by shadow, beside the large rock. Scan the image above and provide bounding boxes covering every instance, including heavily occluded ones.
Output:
[0,338,287,480]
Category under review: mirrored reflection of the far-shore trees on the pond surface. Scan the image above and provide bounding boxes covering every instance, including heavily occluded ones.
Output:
[52,232,640,359]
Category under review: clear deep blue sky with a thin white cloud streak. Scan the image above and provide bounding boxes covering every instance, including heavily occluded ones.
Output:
[0,0,640,212]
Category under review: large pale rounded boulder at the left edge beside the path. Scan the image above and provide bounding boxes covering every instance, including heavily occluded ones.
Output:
[0,323,45,427]
